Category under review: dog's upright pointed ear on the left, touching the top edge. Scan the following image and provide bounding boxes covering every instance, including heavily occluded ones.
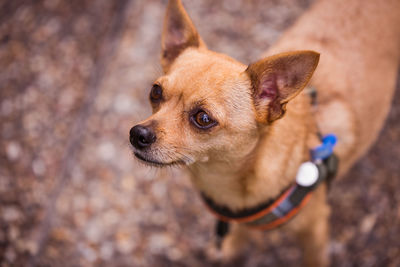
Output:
[161,0,205,73]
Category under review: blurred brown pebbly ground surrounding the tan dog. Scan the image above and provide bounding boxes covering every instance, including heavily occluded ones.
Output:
[0,0,400,266]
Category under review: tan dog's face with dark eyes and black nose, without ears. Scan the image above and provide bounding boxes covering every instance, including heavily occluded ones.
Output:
[131,48,257,164]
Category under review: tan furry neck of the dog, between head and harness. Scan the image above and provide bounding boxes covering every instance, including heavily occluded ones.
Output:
[189,94,318,213]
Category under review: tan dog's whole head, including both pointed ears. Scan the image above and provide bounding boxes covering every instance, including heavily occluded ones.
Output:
[130,0,319,166]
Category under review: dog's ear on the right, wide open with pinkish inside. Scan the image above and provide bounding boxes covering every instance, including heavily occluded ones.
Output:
[246,51,319,123]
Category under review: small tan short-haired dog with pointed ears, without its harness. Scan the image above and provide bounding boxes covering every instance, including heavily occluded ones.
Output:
[129,0,400,266]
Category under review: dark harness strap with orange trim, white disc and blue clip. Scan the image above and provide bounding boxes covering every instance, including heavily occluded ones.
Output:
[202,134,338,231]
